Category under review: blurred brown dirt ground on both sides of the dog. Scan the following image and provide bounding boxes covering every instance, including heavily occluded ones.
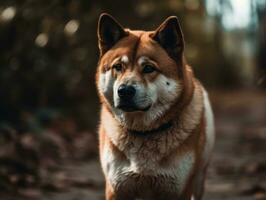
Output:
[0,90,266,200]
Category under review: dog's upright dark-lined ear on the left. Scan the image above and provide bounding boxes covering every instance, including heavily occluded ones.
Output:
[97,13,127,55]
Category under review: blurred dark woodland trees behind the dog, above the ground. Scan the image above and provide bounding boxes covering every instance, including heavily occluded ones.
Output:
[0,0,265,134]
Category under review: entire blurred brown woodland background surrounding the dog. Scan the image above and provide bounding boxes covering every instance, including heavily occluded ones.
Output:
[0,0,266,200]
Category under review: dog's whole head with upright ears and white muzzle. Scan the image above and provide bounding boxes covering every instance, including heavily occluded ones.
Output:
[96,14,192,129]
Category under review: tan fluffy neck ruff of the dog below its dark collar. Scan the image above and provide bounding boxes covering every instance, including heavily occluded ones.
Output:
[102,80,204,155]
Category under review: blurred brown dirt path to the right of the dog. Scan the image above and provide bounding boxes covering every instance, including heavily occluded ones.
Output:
[205,91,266,200]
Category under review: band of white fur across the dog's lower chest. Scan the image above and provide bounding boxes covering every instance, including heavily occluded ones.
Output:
[102,143,195,193]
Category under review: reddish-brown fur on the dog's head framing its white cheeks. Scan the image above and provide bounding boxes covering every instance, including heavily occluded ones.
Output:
[96,30,194,128]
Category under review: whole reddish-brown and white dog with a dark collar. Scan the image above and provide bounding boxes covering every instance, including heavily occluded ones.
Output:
[96,14,214,200]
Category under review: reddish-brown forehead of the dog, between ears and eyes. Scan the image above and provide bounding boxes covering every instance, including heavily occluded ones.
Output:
[101,30,177,77]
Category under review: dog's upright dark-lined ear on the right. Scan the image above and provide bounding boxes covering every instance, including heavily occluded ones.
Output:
[151,16,184,61]
